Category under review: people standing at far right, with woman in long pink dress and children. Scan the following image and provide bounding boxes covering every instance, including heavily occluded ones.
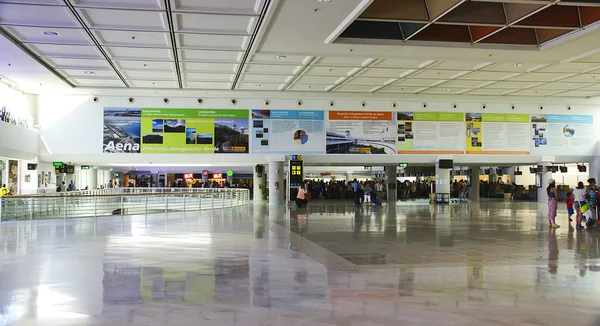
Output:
[546,178,600,229]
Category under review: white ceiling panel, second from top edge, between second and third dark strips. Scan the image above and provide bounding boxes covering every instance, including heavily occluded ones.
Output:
[77,9,168,31]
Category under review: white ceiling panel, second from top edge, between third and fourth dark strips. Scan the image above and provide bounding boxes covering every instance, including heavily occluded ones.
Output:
[173,14,256,35]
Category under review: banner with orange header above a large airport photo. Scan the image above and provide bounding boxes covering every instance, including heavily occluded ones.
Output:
[327,111,398,154]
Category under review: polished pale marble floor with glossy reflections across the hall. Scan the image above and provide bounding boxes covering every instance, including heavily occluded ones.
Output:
[0,201,600,326]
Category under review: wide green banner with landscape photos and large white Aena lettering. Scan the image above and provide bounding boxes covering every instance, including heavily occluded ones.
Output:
[103,108,250,154]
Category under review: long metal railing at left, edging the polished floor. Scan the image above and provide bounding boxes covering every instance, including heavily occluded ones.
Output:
[0,188,250,221]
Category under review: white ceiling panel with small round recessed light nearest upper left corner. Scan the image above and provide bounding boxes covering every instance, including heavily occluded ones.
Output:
[6,26,93,45]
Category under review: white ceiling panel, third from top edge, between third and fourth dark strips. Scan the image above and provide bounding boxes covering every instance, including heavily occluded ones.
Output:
[177,34,248,51]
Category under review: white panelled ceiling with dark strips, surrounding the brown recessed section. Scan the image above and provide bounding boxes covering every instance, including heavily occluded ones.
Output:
[0,0,600,98]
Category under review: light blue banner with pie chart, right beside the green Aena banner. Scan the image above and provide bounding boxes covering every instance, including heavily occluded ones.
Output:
[251,109,325,154]
